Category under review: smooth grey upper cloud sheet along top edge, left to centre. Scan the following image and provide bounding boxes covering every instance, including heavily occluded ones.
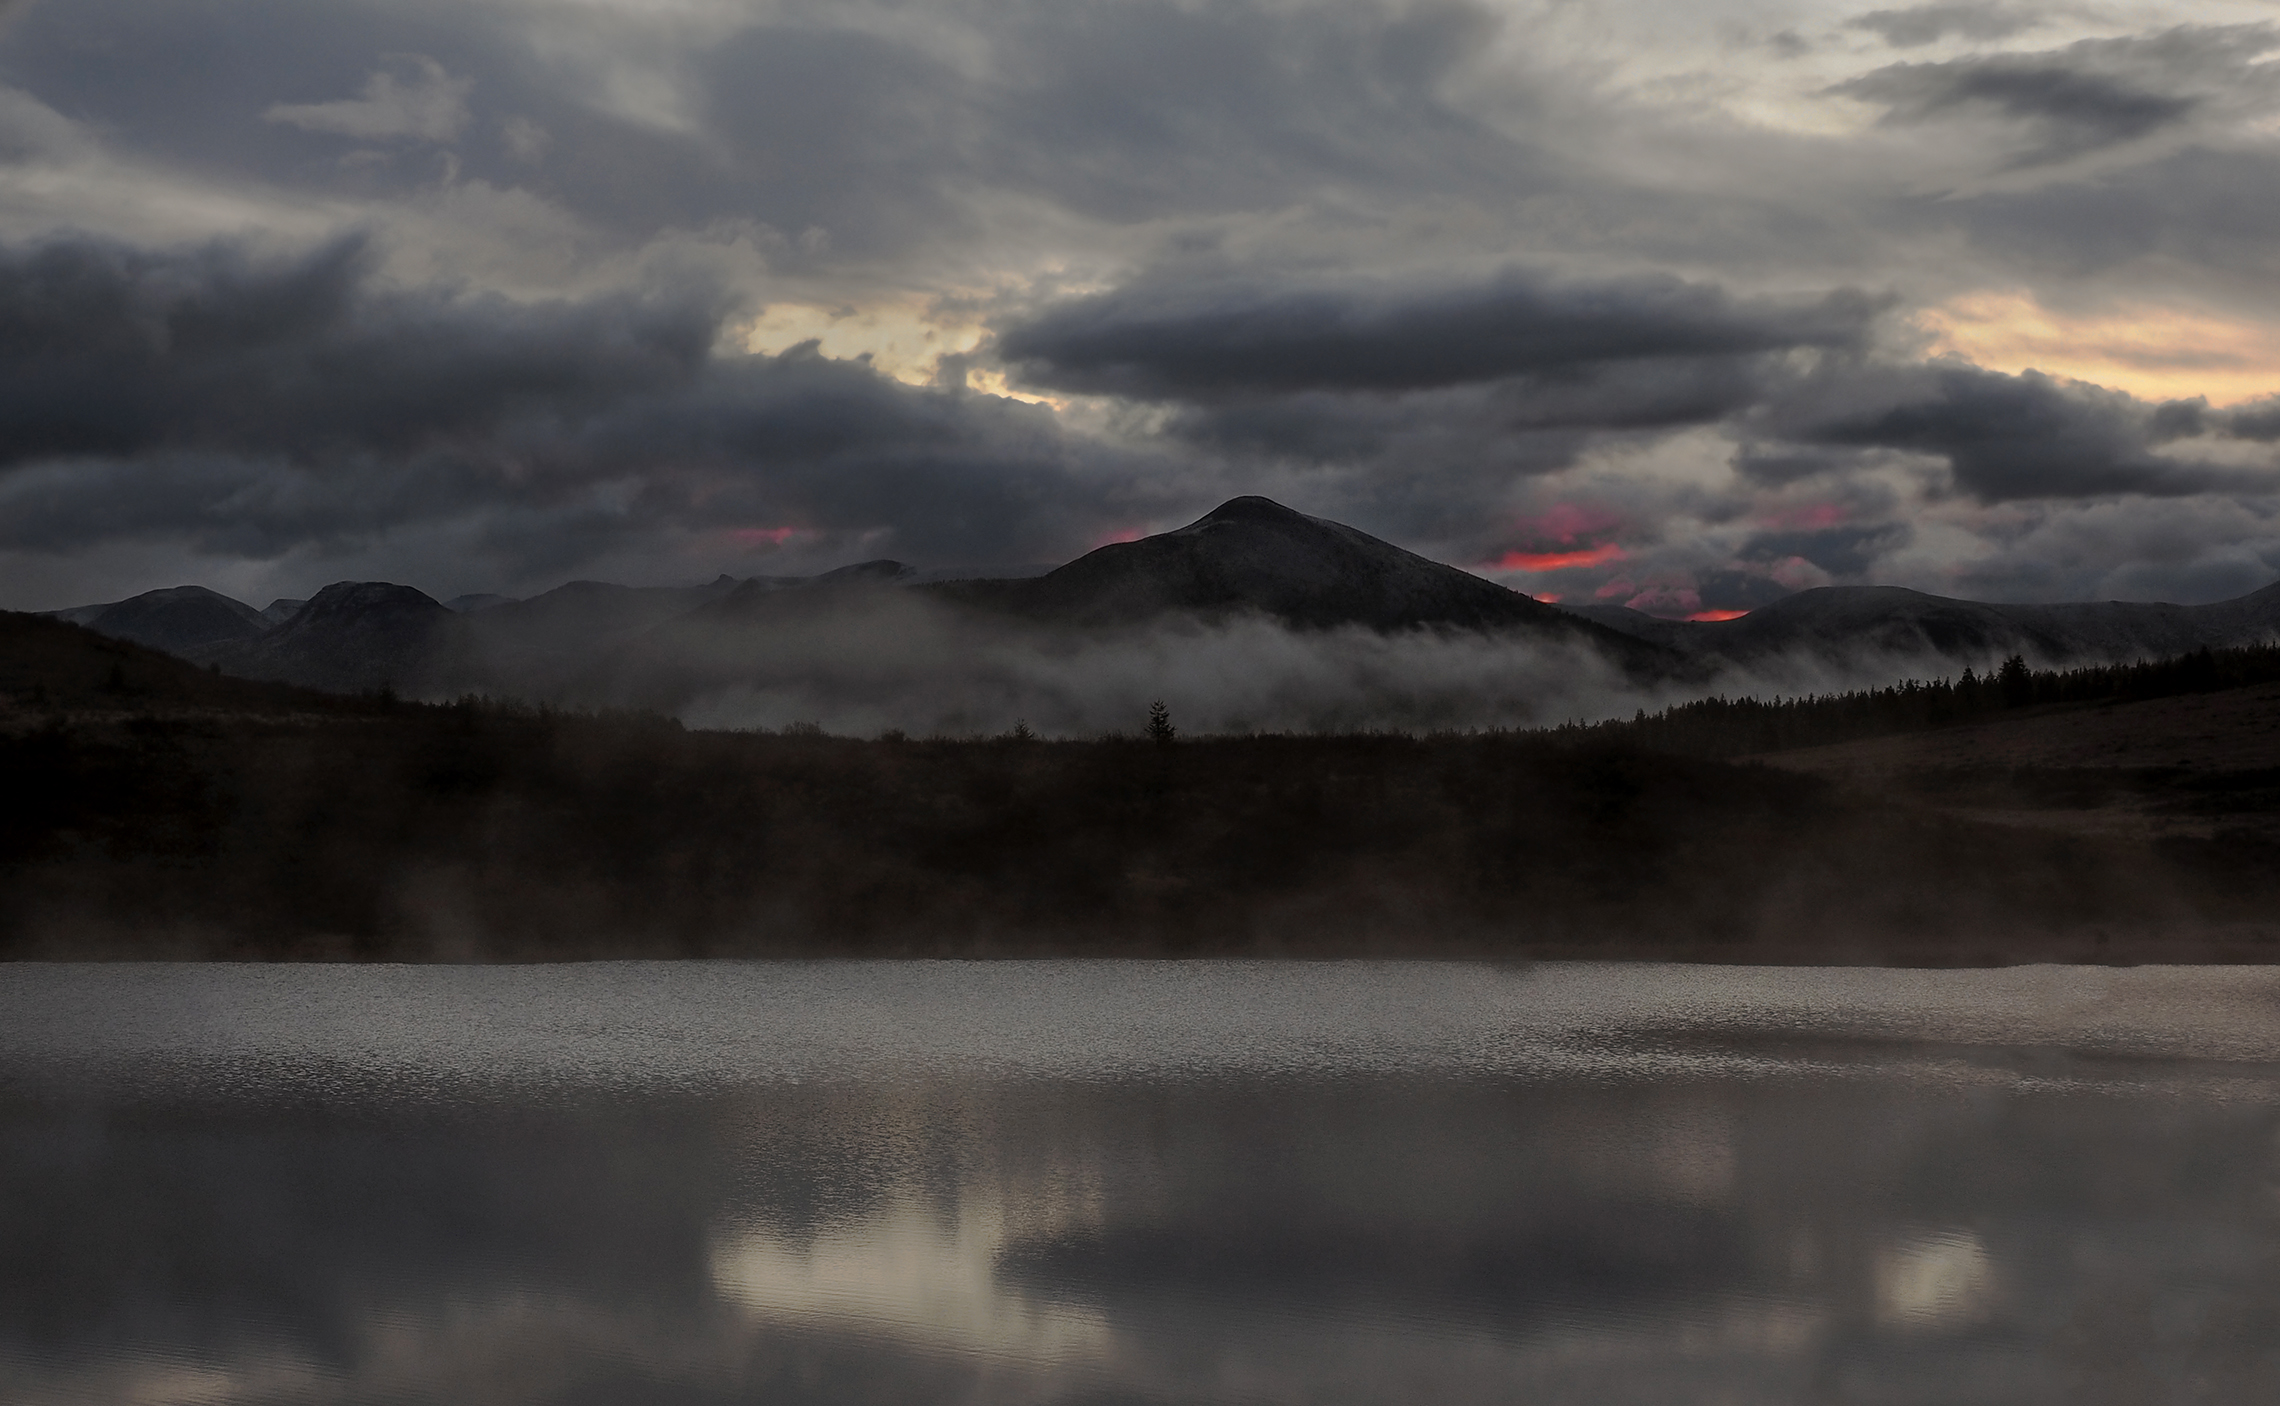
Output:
[0,0,1544,258]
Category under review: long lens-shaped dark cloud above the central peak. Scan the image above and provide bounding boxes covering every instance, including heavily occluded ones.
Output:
[996,271,1879,401]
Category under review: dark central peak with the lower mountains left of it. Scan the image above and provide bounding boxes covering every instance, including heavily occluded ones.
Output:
[52,497,1678,702]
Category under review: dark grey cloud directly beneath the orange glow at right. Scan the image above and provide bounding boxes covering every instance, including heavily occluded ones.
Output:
[1767,362,2275,504]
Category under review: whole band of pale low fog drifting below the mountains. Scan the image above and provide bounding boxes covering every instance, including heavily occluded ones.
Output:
[435,590,2197,738]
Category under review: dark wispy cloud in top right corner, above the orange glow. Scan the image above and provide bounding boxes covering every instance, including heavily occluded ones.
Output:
[1829,25,2280,164]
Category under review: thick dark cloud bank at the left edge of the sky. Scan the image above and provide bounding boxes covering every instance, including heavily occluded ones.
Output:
[0,239,720,469]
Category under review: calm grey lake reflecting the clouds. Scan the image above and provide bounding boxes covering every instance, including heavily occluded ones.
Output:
[0,962,2280,1406]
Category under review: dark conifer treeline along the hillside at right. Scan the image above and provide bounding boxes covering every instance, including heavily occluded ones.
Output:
[1550,645,2280,757]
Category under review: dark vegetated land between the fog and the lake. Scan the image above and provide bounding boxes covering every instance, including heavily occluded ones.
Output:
[0,618,2280,962]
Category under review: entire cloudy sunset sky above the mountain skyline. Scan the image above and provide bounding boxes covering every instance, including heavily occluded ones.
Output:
[0,0,2280,615]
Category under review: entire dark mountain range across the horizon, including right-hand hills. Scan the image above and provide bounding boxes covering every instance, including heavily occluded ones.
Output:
[35,497,2280,709]
